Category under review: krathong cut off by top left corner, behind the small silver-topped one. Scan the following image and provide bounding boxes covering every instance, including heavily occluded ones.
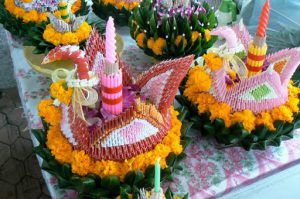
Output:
[0,0,92,37]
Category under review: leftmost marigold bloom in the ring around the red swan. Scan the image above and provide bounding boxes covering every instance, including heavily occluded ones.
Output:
[38,99,61,126]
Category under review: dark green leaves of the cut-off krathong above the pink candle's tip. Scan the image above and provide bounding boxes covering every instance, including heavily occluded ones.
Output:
[93,0,131,26]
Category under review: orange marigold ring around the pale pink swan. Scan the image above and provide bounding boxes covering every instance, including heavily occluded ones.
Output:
[184,64,300,132]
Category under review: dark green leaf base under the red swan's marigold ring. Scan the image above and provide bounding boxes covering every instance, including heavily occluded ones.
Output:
[33,110,191,199]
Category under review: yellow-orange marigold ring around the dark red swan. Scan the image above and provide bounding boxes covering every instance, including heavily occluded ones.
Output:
[39,94,183,179]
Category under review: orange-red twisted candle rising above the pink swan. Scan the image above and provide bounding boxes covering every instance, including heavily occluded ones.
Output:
[256,0,270,37]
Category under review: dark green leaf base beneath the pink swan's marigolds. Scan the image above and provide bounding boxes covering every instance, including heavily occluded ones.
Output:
[176,88,300,150]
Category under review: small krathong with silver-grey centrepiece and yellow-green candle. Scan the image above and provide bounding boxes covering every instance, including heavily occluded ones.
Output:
[24,0,92,54]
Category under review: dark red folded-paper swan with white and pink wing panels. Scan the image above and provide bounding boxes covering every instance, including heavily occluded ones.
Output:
[45,30,194,161]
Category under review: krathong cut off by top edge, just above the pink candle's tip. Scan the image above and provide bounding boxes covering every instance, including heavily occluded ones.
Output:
[93,0,141,26]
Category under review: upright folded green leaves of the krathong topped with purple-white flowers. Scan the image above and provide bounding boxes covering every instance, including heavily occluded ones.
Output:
[129,0,217,60]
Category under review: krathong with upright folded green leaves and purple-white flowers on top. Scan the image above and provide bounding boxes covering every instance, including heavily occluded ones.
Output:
[129,0,217,60]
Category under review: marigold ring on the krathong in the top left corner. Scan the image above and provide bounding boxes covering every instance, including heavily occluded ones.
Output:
[4,0,81,23]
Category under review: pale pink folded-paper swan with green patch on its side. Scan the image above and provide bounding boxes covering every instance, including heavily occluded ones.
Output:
[211,23,300,113]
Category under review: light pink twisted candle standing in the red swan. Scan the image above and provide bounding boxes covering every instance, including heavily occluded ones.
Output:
[105,17,117,64]
